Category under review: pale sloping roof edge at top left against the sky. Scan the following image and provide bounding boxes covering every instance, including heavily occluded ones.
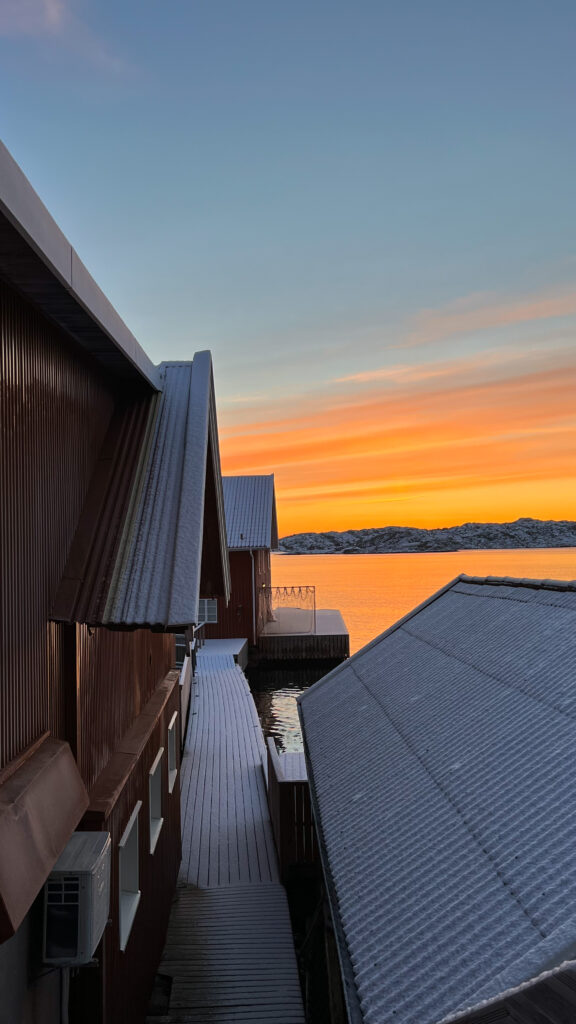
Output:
[0,141,158,388]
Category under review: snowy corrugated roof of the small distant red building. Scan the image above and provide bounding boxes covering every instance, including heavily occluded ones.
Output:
[222,474,278,550]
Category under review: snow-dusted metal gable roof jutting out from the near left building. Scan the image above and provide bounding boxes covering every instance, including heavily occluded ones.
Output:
[101,352,230,629]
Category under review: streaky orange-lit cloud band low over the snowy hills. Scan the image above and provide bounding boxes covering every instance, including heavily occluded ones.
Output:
[220,347,576,532]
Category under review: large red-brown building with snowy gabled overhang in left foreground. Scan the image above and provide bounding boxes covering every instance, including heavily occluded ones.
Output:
[0,145,230,1024]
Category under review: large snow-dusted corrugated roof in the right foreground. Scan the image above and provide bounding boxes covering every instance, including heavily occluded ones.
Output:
[299,577,576,1024]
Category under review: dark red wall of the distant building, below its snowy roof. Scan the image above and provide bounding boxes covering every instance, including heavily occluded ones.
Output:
[205,550,271,644]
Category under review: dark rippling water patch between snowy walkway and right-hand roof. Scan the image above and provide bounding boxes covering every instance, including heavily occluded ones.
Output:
[246,665,331,753]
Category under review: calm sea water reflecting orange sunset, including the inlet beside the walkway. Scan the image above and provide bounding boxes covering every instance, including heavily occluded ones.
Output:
[251,548,576,751]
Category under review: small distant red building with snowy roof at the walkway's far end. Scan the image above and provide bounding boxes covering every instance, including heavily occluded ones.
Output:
[205,475,278,645]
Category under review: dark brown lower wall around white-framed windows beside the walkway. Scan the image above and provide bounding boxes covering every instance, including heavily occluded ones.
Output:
[76,672,181,1024]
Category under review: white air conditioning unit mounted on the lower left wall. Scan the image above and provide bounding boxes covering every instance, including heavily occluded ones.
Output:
[42,831,111,967]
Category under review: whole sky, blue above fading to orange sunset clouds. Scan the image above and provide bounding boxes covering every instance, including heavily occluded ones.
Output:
[0,0,576,535]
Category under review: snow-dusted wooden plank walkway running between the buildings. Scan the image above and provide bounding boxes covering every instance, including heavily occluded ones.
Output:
[149,652,304,1024]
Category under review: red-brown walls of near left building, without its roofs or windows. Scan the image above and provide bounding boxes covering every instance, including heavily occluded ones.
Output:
[0,282,180,1024]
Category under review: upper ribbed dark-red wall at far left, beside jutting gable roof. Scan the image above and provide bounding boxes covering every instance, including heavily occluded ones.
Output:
[0,281,114,767]
